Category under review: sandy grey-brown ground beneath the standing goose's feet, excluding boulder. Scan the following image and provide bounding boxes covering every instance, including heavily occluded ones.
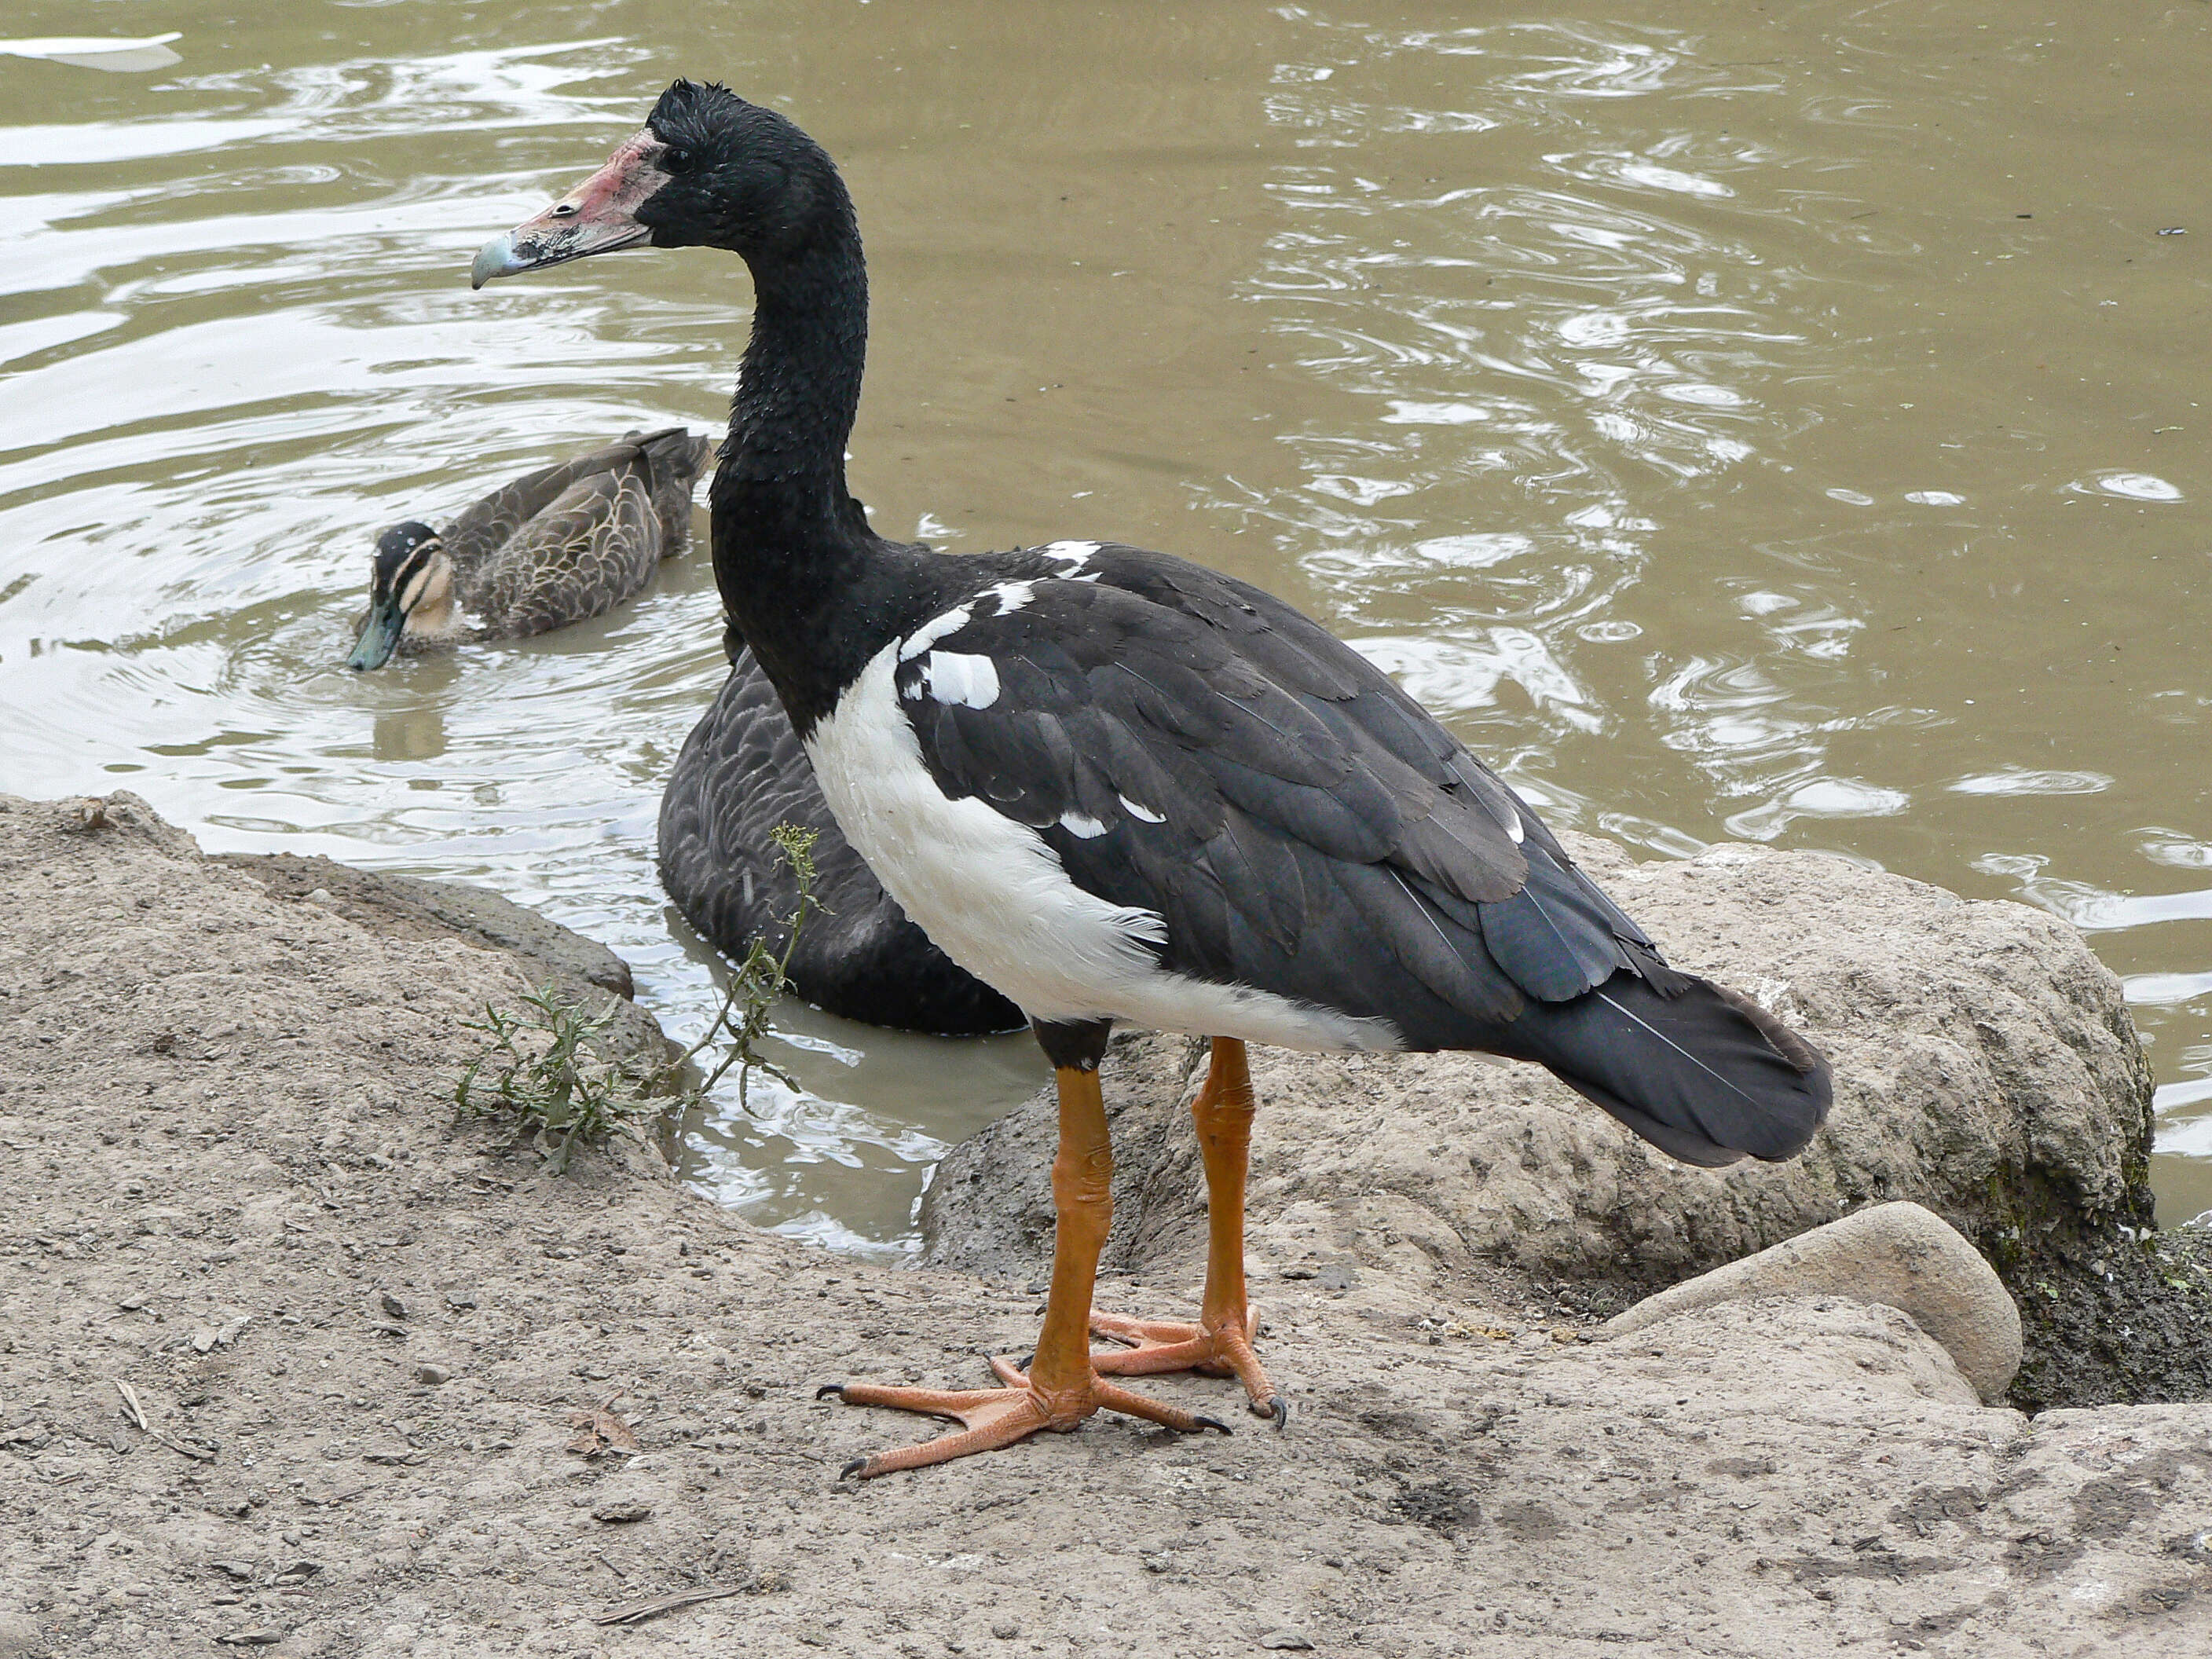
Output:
[13,797,2212,1659]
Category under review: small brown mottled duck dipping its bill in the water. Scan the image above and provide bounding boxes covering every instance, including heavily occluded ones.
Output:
[345,427,715,670]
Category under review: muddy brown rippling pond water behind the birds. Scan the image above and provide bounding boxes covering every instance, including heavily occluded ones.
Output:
[0,0,2212,1250]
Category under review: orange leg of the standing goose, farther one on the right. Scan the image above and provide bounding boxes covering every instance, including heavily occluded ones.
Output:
[1090,1038,1290,1429]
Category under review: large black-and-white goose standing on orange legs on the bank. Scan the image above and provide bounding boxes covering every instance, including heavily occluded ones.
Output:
[471,79,1833,1480]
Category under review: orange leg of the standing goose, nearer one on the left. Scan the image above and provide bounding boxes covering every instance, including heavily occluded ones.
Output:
[816,1066,1228,1480]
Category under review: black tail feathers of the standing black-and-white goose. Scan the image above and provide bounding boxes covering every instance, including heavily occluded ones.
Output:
[1515,969,1833,1168]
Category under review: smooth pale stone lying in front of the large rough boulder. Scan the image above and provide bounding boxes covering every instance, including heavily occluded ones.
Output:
[1606,1201,2020,1404]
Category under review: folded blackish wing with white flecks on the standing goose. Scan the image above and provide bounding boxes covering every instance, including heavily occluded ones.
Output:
[895,548,1670,1046]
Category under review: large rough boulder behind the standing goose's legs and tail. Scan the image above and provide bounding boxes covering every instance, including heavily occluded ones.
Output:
[922,838,2150,1290]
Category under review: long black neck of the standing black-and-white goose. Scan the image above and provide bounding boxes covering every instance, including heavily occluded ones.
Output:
[712,174,925,734]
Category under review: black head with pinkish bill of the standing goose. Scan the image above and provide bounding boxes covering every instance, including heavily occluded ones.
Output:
[469,79,851,287]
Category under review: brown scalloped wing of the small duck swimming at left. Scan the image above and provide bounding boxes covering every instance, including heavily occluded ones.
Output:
[463,460,661,639]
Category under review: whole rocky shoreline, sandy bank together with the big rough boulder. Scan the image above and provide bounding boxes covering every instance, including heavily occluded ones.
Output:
[0,797,2212,1659]
